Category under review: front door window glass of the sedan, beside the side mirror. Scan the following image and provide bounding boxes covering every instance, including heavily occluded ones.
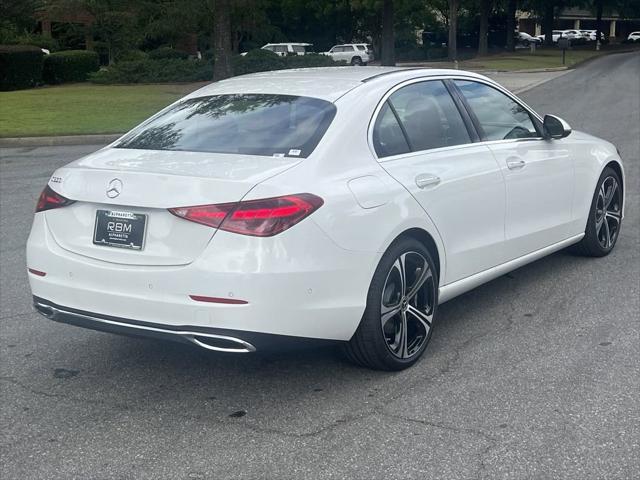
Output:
[455,80,540,140]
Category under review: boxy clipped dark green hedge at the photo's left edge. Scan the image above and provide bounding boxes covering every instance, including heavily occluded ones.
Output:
[0,45,44,90]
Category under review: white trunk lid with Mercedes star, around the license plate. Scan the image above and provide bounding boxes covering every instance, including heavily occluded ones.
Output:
[45,148,300,265]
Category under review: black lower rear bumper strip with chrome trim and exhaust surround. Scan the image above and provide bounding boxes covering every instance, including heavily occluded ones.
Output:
[33,296,332,353]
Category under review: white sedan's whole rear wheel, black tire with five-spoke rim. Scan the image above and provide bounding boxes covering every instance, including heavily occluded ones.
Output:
[344,237,438,370]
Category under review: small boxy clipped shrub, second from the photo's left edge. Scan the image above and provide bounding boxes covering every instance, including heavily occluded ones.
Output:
[42,50,99,84]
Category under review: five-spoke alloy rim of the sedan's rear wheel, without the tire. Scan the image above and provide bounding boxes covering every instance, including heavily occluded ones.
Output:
[380,251,436,359]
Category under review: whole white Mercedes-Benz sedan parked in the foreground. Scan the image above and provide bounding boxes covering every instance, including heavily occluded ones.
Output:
[27,67,624,370]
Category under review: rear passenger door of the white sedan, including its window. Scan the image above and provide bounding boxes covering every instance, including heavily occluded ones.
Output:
[371,80,505,284]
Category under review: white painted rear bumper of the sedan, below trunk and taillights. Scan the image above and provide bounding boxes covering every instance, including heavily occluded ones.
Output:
[27,214,378,343]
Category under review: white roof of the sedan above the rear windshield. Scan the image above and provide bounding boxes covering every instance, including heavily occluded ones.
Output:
[188,67,485,102]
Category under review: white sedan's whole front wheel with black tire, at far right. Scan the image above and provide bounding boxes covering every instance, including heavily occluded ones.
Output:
[574,167,623,257]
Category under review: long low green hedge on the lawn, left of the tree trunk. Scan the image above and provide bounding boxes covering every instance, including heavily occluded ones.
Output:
[89,59,213,84]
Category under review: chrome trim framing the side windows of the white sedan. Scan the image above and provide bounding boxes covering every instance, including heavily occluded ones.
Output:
[367,74,545,163]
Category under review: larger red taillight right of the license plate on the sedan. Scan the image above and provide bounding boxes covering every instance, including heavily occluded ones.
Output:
[169,193,324,237]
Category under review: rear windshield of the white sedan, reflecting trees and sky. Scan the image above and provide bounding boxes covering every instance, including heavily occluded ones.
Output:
[116,94,336,157]
